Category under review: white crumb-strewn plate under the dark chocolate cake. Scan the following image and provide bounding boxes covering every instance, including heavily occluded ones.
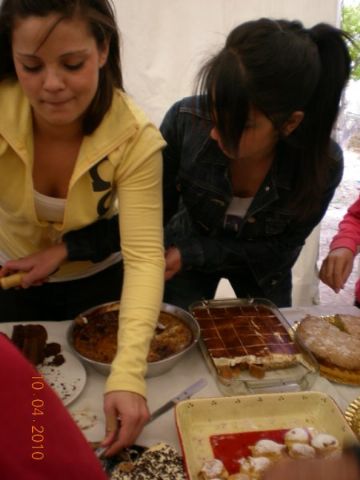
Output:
[0,321,86,405]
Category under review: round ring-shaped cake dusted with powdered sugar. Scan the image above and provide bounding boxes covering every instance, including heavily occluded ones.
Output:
[295,313,360,386]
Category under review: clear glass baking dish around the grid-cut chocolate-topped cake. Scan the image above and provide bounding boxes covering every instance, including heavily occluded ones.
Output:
[190,298,319,395]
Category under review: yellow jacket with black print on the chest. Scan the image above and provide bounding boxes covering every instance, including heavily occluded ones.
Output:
[0,81,164,396]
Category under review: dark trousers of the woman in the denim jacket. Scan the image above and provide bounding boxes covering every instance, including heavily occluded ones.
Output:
[164,270,291,310]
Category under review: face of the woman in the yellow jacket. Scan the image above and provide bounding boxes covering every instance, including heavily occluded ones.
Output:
[12,14,108,131]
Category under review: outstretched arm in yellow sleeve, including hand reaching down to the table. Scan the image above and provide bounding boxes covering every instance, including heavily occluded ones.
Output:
[104,122,164,455]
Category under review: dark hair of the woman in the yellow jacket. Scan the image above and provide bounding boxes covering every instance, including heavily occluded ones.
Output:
[0,0,123,134]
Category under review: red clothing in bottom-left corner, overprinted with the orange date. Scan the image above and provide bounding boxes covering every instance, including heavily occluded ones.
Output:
[0,334,106,480]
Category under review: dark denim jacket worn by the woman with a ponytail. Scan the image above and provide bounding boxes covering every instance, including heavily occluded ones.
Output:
[160,97,343,294]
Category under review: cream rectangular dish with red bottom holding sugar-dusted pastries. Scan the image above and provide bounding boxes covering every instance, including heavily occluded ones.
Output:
[175,392,356,480]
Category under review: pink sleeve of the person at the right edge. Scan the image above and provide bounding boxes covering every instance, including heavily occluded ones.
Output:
[330,197,360,254]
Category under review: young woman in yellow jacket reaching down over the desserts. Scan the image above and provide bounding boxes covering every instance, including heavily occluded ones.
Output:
[0,0,164,455]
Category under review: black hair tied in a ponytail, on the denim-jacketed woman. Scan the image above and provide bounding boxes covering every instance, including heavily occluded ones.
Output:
[197,18,351,218]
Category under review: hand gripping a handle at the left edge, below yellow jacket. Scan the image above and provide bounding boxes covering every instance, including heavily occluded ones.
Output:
[0,243,67,288]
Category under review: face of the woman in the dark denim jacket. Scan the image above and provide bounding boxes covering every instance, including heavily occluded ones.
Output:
[210,108,279,161]
